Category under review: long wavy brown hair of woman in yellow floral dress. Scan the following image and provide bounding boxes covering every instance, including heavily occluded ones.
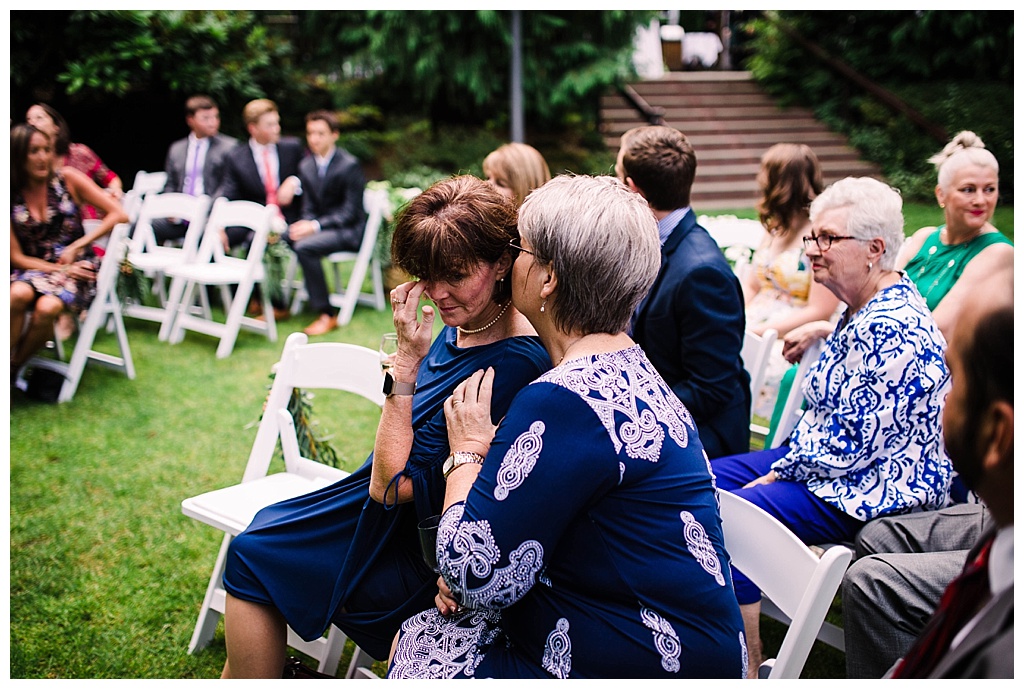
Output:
[758,143,824,232]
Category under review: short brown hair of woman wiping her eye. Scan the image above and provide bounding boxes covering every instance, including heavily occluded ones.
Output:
[391,175,519,302]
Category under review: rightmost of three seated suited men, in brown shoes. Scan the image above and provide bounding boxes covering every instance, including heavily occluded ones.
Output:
[286,111,367,335]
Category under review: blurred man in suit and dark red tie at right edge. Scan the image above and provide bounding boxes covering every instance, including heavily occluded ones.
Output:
[843,269,1014,679]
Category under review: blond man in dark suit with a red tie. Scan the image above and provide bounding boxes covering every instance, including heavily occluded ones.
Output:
[214,98,305,247]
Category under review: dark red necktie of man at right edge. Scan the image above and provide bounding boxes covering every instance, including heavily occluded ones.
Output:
[893,536,994,679]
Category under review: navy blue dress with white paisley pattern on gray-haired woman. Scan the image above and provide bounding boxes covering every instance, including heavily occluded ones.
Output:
[389,346,746,679]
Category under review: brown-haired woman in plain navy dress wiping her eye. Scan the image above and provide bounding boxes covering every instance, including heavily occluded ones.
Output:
[218,176,550,678]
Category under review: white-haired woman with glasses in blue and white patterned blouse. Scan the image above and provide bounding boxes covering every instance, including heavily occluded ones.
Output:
[712,177,952,676]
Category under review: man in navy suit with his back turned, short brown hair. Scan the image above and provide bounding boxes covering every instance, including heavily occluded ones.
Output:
[615,126,751,458]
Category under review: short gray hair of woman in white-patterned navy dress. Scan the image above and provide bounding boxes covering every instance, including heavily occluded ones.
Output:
[519,175,662,334]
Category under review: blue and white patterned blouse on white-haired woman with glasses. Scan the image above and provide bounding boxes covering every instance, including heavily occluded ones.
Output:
[772,274,952,521]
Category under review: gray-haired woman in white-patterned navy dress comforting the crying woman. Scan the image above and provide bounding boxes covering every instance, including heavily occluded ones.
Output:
[389,176,744,679]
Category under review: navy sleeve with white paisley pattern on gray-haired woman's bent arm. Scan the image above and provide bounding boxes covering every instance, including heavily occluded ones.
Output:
[437,383,618,609]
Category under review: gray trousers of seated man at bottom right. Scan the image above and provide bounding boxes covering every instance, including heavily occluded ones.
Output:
[843,504,990,679]
